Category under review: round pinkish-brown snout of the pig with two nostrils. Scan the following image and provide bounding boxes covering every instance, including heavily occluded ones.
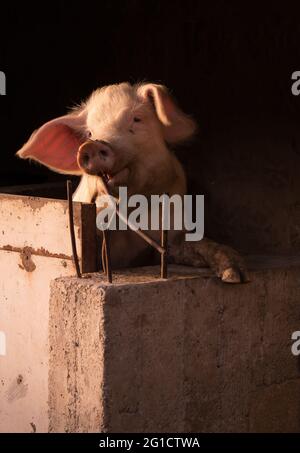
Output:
[77,140,115,175]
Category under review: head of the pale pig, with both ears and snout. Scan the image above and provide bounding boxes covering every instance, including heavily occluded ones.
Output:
[17,83,196,194]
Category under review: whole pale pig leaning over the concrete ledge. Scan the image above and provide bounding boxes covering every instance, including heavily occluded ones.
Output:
[17,82,248,283]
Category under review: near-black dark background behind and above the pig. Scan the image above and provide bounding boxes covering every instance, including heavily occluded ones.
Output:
[0,0,300,253]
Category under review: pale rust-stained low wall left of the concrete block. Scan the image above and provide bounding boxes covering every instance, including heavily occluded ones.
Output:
[0,194,95,432]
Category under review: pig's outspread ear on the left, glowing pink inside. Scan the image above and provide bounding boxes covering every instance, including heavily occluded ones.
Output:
[17,110,86,175]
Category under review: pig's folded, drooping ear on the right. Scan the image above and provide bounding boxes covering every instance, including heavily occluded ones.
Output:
[138,83,197,143]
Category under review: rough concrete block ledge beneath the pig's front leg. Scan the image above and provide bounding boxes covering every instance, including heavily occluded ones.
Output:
[49,257,300,432]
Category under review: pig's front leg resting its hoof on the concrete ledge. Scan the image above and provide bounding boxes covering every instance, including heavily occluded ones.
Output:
[169,237,249,283]
